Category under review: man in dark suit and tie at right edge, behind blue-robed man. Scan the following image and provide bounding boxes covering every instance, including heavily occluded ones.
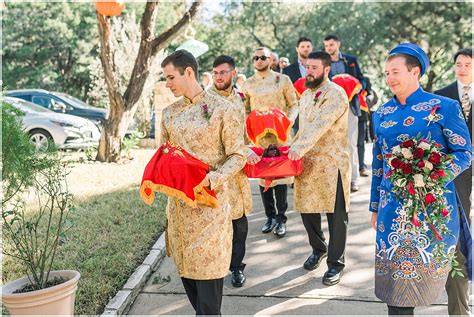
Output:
[435,48,474,315]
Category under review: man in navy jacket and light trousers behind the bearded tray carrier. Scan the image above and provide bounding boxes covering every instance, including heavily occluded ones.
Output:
[324,34,367,192]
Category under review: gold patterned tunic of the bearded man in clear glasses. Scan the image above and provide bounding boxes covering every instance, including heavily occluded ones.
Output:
[208,85,252,220]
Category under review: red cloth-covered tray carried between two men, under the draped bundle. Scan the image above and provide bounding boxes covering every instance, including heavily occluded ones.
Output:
[244,146,303,190]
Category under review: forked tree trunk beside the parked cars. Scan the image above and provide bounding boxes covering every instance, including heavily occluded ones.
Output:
[96,1,201,162]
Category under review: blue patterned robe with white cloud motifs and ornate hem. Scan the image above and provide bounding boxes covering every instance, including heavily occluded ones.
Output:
[370,88,471,307]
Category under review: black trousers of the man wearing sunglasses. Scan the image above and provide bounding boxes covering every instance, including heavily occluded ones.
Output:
[259,185,288,223]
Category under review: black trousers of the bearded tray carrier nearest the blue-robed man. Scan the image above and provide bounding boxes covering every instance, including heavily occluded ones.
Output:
[301,173,349,271]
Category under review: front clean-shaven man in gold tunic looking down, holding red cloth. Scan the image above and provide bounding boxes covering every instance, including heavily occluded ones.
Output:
[161,50,246,315]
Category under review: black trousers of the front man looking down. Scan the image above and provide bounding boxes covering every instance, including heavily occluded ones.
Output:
[181,277,224,315]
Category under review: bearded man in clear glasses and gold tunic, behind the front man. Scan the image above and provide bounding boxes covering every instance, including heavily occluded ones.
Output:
[208,55,252,287]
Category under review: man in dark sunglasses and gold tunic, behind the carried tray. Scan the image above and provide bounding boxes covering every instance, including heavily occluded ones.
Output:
[242,47,298,237]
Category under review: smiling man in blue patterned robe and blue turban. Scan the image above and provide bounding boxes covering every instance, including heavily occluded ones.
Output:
[369,43,471,315]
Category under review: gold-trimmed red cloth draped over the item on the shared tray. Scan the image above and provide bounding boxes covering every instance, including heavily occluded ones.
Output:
[246,108,291,144]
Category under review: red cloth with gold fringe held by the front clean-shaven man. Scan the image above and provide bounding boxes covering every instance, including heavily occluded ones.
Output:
[140,141,218,208]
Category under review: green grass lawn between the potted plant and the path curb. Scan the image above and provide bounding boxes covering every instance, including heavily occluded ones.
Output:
[3,187,166,314]
